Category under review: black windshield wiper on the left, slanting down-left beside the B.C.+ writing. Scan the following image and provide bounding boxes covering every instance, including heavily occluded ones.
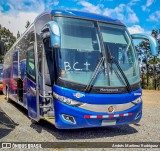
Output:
[85,54,105,92]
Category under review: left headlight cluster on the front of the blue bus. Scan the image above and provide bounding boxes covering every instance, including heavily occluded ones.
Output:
[53,92,83,107]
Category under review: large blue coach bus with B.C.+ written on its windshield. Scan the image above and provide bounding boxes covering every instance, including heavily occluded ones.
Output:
[3,10,157,129]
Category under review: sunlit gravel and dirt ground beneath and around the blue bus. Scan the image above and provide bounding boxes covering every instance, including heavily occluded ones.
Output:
[0,90,160,151]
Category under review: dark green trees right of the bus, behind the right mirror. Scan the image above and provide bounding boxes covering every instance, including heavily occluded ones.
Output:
[136,30,160,89]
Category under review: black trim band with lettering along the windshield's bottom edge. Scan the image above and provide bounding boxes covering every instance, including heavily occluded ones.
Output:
[56,78,141,94]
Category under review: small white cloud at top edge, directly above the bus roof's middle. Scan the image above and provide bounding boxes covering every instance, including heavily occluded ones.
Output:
[78,1,103,14]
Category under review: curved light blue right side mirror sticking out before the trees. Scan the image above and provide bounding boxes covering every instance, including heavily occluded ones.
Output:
[131,33,158,55]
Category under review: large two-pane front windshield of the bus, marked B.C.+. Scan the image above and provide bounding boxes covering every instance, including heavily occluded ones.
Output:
[56,17,140,87]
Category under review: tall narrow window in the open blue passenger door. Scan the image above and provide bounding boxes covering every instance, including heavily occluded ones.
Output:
[27,47,36,81]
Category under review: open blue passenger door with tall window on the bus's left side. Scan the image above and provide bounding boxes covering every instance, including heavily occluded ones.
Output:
[26,45,39,121]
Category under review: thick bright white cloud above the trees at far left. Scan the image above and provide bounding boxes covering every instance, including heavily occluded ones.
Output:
[0,12,38,36]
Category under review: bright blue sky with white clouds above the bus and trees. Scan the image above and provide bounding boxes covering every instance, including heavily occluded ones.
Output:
[0,0,160,36]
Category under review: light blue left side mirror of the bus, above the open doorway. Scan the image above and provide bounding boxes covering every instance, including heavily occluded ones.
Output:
[41,21,61,48]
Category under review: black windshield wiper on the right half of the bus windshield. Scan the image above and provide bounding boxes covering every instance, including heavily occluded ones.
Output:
[106,44,132,92]
